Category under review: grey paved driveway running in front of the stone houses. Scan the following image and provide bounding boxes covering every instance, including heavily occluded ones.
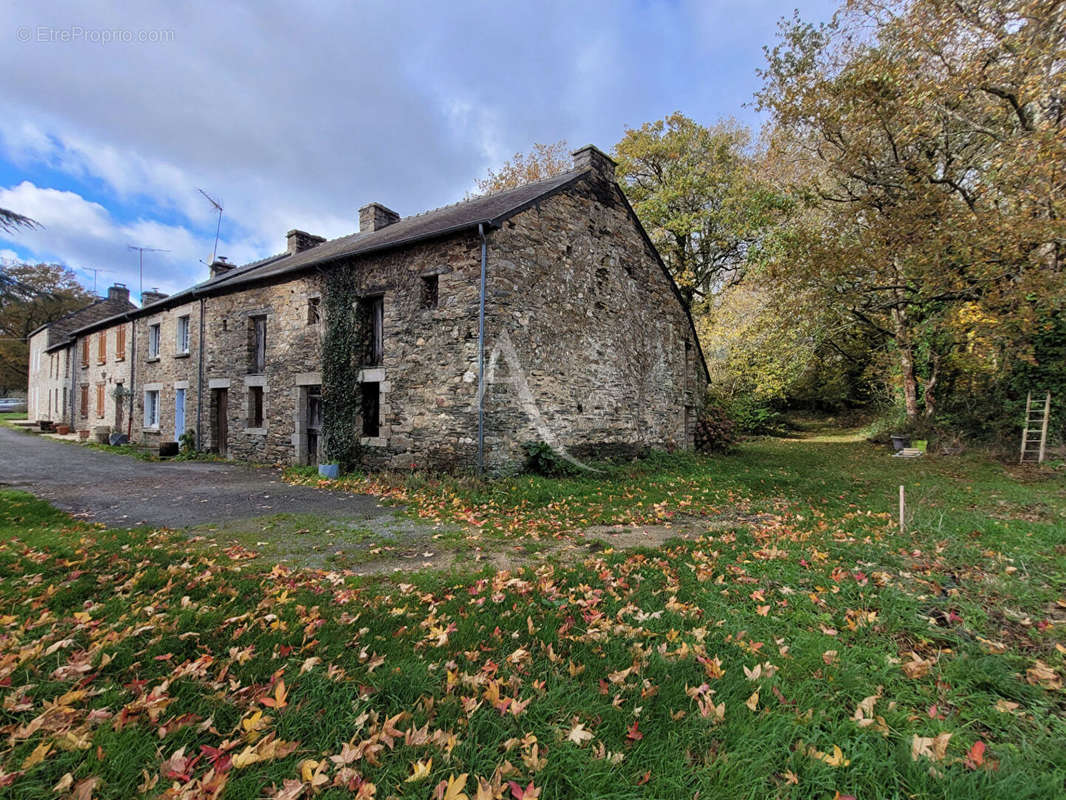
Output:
[0,426,394,528]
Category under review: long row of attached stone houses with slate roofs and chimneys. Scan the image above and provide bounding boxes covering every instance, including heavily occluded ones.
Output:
[30,146,707,470]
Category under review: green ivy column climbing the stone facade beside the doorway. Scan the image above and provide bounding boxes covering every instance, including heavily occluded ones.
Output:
[322,267,364,471]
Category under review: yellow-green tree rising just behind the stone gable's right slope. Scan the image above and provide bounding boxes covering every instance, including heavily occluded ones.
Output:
[614,112,780,305]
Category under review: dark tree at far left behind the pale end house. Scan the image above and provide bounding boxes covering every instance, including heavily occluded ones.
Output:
[0,263,95,391]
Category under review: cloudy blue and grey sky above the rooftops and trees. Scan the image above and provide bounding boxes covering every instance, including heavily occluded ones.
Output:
[0,0,836,295]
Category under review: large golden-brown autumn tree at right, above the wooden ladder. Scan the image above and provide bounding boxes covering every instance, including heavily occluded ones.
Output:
[759,0,1066,421]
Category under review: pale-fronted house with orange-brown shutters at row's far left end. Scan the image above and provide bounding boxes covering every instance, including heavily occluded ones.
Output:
[27,284,136,428]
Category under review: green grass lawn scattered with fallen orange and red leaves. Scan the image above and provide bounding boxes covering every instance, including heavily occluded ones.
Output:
[0,435,1066,800]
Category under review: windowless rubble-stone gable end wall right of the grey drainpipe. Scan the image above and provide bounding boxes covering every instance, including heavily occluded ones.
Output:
[485,173,706,470]
